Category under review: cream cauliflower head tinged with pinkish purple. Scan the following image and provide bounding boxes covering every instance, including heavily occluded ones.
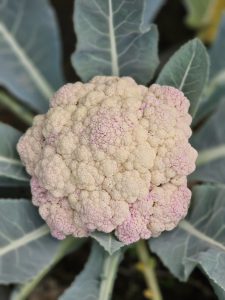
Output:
[17,76,197,244]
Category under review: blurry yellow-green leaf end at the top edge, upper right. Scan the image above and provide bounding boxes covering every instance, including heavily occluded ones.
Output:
[184,0,215,28]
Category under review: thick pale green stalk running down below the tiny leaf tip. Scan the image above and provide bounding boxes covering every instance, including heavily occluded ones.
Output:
[98,251,121,300]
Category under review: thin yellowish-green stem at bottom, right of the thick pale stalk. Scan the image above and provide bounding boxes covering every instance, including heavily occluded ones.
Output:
[137,240,163,300]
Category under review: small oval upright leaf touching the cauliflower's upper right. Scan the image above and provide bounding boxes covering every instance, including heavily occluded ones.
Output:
[157,39,209,116]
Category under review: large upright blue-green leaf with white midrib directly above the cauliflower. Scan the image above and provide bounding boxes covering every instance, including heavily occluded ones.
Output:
[72,0,162,84]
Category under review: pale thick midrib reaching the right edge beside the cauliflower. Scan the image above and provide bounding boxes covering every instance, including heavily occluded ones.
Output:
[196,144,225,166]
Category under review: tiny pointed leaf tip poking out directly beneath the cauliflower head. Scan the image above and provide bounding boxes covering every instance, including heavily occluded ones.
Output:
[91,231,125,255]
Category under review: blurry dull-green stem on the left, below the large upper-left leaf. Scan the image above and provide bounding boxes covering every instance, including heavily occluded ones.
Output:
[0,91,34,125]
